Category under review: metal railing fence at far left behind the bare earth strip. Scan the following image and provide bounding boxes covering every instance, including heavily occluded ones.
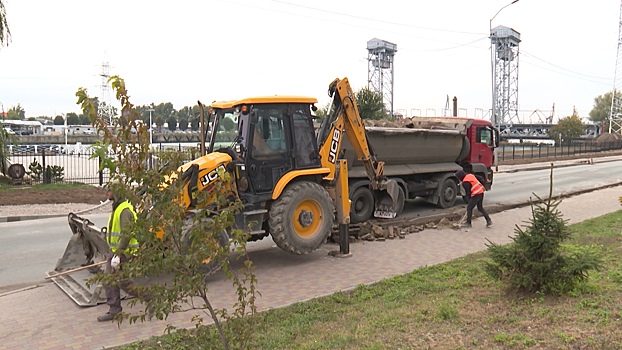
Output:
[0,146,198,186]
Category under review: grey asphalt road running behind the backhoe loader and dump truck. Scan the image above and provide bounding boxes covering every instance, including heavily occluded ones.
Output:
[0,161,622,293]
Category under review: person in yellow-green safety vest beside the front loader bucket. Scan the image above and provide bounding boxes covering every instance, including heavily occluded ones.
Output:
[97,185,138,322]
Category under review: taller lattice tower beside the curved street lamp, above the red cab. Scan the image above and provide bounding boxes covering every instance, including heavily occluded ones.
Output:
[490,26,521,129]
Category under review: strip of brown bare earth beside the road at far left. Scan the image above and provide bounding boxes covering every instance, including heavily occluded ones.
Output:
[0,186,106,206]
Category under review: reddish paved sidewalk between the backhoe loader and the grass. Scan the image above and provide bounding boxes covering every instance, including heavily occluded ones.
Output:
[0,186,622,349]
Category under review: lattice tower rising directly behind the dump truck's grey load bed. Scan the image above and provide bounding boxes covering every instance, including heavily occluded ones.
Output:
[367,38,397,116]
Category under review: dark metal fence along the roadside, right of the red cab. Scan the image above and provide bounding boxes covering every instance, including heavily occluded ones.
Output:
[497,140,622,161]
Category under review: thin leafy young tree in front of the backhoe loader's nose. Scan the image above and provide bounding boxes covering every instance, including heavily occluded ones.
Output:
[76,76,258,349]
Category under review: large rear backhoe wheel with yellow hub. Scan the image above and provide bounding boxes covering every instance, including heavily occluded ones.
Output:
[268,181,334,255]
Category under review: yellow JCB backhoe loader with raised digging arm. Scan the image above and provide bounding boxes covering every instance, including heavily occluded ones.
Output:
[50,78,399,304]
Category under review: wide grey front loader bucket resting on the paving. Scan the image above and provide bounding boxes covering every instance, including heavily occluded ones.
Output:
[47,213,110,306]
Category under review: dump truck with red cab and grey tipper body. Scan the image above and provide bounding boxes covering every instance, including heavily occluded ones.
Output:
[342,117,499,223]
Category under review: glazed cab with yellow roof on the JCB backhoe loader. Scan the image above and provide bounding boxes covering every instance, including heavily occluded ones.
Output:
[208,96,320,197]
